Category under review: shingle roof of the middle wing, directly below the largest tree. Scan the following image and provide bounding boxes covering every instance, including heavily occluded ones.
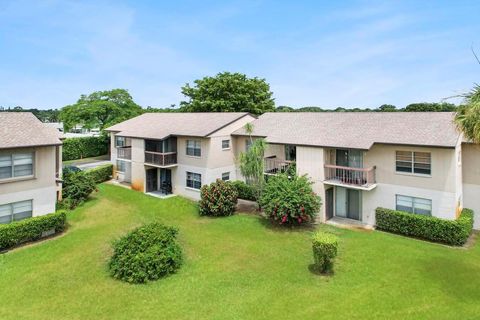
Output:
[106,112,248,139]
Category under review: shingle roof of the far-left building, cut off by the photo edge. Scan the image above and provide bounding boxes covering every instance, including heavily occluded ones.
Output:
[0,112,62,149]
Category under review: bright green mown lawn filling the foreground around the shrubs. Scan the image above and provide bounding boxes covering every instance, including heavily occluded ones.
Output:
[0,185,480,320]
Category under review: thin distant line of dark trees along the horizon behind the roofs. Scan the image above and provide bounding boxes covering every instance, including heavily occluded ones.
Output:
[0,102,459,122]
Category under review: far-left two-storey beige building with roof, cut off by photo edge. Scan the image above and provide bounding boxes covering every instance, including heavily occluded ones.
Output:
[0,112,62,223]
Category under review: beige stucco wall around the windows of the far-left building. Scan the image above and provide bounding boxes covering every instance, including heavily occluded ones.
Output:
[0,146,61,216]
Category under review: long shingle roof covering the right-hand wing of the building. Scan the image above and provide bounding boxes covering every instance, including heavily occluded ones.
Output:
[233,112,459,150]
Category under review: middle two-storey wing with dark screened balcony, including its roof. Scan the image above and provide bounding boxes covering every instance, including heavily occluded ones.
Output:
[106,113,255,199]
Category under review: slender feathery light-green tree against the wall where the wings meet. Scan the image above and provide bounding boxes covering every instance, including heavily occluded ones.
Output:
[239,123,267,199]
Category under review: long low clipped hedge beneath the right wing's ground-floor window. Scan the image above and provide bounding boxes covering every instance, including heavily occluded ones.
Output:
[375,208,473,246]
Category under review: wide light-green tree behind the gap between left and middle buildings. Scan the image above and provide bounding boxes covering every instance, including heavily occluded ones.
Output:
[60,89,142,130]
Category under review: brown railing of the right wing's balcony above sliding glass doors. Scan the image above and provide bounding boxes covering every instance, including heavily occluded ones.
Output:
[324,164,376,188]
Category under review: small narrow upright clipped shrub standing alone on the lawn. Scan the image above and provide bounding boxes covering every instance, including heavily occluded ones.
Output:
[312,231,338,273]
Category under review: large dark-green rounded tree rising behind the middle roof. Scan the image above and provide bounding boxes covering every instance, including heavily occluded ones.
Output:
[180,72,275,115]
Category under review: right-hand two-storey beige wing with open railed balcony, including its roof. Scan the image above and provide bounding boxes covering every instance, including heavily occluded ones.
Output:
[233,112,480,228]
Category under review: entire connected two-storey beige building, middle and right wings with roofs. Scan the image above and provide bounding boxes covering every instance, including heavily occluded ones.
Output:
[108,112,480,228]
